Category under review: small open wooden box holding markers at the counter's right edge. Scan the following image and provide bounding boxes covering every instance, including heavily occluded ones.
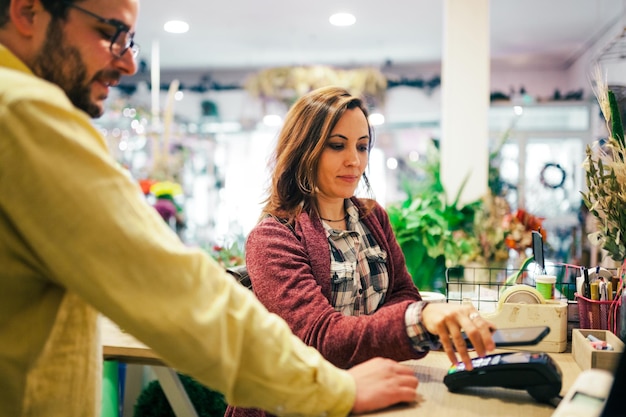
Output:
[572,329,624,372]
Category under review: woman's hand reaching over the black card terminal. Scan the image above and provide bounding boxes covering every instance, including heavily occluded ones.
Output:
[422,303,496,370]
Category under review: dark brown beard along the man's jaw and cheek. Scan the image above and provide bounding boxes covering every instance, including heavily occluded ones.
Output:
[33,19,103,118]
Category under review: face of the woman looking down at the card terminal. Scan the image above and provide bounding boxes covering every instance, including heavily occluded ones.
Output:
[316,108,370,203]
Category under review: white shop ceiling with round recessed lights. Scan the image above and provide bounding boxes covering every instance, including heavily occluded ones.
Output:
[135,0,625,70]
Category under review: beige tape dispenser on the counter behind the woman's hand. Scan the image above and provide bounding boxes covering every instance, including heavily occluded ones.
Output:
[483,284,567,352]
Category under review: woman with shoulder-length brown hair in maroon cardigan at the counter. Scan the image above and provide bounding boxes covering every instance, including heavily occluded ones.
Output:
[227,87,495,415]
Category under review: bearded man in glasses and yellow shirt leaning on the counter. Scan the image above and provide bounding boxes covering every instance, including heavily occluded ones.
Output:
[0,0,417,417]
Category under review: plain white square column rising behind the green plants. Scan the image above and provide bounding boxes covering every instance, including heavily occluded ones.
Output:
[441,0,490,203]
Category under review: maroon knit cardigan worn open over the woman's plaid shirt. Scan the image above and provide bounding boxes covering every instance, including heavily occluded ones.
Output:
[226,198,426,417]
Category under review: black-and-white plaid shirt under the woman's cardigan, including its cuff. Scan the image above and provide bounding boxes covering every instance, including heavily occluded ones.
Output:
[322,200,440,351]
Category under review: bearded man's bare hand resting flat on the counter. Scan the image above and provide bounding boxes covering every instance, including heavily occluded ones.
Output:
[348,358,418,414]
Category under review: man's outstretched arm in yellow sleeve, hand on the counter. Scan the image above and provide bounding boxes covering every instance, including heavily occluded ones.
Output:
[3,93,412,416]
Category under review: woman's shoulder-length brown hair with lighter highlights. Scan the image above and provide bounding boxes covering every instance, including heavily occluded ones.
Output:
[261,87,374,223]
